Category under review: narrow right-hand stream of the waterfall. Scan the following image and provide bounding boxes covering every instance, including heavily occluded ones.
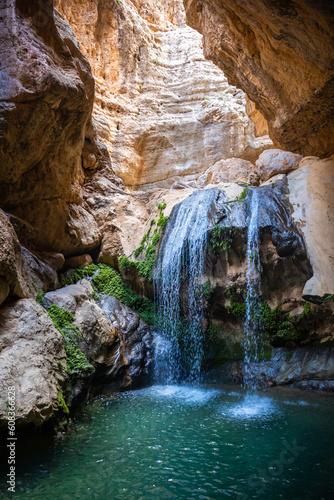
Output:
[244,189,263,389]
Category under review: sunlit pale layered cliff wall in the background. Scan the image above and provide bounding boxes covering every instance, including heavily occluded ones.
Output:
[56,0,271,190]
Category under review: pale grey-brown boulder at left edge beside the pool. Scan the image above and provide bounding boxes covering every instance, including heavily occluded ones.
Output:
[0,299,66,425]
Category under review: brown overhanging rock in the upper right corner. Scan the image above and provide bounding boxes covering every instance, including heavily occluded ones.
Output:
[184,0,334,157]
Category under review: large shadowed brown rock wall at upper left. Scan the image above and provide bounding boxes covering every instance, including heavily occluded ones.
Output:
[0,0,102,252]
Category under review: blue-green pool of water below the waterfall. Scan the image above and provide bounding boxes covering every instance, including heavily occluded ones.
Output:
[0,386,334,500]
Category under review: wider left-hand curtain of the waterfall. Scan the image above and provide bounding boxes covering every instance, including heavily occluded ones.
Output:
[153,189,218,383]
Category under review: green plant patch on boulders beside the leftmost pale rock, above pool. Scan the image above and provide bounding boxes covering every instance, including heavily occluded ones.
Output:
[47,304,93,375]
